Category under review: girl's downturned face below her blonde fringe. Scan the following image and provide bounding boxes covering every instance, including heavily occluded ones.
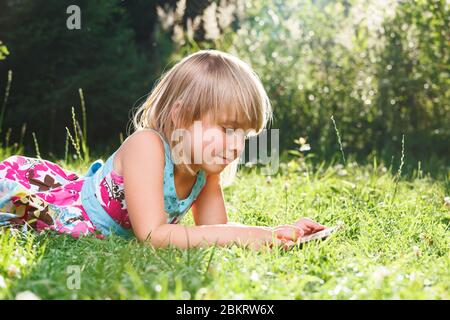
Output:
[177,114,248,174]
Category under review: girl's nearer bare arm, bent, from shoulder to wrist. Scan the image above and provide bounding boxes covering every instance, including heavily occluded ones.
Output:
[121,131,282,248]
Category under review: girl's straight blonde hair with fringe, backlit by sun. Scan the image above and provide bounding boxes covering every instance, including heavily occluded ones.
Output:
[128,49,272,185]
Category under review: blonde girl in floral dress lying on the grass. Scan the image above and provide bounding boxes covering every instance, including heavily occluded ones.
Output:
[0,50,324,249]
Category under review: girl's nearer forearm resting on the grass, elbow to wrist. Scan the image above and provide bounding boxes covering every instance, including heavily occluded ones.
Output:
[149,224,273,249]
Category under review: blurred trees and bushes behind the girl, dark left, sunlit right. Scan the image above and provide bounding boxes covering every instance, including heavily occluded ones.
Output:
[0,0,450,166]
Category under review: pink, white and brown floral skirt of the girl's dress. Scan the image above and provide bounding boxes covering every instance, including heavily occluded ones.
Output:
[0,155,104,238]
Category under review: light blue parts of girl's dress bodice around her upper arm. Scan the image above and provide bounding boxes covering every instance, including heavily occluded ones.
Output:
[81,129,206,238]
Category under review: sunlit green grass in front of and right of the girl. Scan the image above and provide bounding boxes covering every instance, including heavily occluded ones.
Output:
[0,155,450,299]
